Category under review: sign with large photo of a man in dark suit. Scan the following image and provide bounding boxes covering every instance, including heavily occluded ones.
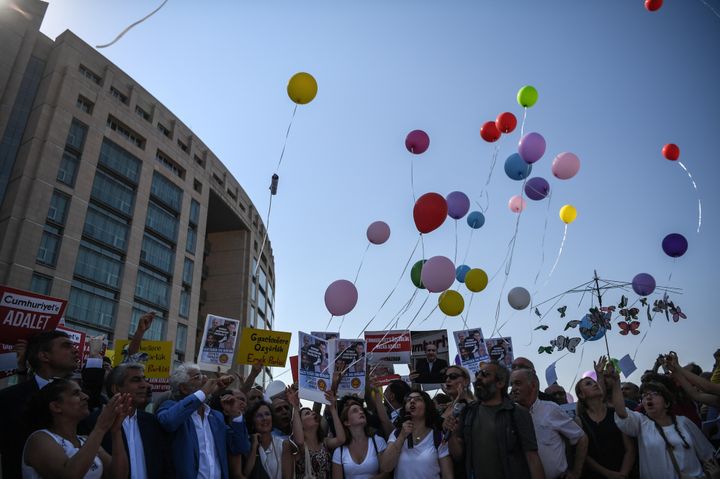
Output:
[410,329,450,389]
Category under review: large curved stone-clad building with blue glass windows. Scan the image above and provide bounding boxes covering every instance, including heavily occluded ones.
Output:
[0,0,275,382]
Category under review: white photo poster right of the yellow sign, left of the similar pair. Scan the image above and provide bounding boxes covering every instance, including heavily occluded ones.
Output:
[298,331,334,404]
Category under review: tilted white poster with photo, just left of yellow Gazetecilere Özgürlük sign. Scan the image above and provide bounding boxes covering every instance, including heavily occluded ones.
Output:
[198,314,240,372]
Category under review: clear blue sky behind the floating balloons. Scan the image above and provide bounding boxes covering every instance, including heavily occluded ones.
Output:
[42,0,720,387]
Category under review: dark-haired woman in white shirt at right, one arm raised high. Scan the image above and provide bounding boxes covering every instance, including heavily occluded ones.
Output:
[605,364,713,479]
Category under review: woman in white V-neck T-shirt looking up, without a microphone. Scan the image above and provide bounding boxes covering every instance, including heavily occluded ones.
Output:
[332,400,389,479]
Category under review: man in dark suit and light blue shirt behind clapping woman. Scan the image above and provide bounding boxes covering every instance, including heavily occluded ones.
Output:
[79,363,174,479]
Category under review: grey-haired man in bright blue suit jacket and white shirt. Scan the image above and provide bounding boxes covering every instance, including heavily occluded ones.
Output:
[157,363,250,479]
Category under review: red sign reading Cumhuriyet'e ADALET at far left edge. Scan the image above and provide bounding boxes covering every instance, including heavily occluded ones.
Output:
[0,286,67,344]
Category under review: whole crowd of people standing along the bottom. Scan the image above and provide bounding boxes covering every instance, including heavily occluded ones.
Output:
[0,318,720,479]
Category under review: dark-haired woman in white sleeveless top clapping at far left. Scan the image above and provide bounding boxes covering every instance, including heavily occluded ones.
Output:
[22,379,132,479]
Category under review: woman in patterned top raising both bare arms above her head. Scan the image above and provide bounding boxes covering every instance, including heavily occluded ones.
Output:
[283,388,345,479]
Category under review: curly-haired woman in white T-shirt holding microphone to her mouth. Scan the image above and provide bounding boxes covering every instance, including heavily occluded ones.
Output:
[380,391,453,479]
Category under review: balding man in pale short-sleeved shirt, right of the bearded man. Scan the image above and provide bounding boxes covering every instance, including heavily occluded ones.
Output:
[510,369,588,479]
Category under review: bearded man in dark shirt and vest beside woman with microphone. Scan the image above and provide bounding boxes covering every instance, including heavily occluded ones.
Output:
[444,361,544,479]
